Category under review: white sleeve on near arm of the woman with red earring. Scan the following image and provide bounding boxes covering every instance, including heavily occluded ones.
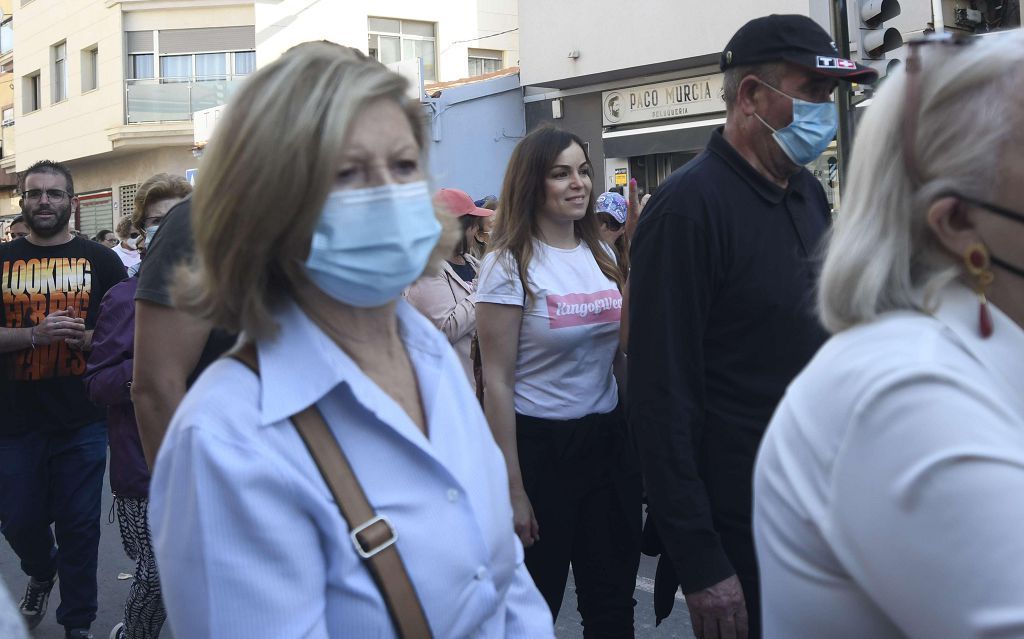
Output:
[831,374,1024,638]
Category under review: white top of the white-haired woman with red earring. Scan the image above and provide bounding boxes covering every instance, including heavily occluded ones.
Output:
[754,285,1024,639]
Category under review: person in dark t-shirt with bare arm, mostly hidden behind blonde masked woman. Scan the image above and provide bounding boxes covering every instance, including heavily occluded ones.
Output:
[131,198,236,468]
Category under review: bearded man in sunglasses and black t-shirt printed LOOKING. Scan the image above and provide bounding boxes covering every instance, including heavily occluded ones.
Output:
[0,161,125,639]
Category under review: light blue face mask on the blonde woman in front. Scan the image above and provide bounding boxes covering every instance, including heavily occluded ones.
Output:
[306,181,441,308]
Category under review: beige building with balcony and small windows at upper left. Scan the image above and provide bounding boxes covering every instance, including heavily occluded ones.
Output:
[12,0,256,235]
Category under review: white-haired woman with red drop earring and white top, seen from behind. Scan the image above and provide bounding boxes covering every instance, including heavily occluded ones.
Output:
[754,32,1024,639]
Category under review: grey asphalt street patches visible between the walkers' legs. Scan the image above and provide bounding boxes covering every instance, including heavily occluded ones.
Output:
[0,460,693,639]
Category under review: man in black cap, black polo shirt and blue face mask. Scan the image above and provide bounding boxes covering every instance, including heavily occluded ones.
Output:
[629,15,876,639]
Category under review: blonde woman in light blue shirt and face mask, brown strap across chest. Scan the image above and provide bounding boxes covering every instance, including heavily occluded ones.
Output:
[150,42,553,639]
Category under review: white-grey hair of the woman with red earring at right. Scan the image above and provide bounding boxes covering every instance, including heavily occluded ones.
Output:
[818,32,1024,333]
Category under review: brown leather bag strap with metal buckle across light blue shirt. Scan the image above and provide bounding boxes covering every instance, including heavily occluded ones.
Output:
[227,342,432,639]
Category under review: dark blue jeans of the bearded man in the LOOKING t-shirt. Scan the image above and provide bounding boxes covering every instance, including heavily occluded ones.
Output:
[0,422,106,629]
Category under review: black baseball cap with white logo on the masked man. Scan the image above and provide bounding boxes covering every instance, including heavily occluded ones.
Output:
[719,14,879,84]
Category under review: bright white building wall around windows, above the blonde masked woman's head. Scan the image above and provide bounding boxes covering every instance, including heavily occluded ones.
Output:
[256,0,519,82]
